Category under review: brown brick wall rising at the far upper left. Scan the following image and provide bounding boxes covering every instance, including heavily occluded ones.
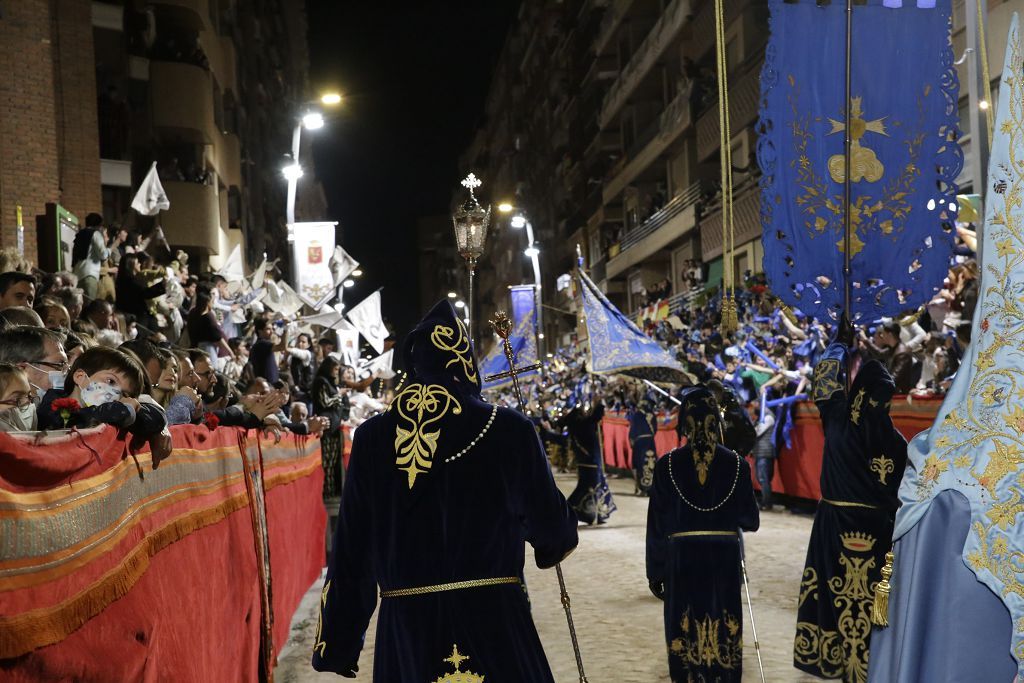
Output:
[0,0,101,260]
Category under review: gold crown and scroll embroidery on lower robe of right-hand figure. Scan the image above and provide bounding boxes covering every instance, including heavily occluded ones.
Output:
[794,532,878,683]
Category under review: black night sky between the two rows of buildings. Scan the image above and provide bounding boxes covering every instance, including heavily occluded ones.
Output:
[299,0,519,339]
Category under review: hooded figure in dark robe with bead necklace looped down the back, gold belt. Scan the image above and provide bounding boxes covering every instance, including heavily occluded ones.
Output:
[647,387,760,683]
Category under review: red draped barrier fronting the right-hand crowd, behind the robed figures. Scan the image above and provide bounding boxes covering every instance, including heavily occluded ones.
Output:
[602,396,942,501]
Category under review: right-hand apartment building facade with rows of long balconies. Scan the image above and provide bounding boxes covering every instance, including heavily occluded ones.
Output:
[463,0,1024,341]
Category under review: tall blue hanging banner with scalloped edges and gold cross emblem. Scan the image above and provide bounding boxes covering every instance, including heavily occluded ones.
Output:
[758,0,963,321]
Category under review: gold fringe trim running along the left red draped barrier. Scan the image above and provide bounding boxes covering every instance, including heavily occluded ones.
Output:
[0,463,319,659]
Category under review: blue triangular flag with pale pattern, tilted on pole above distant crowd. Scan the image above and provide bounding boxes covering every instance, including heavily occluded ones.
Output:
[580,272,693,385]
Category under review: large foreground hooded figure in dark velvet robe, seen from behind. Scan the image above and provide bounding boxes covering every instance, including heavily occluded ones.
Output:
[312,301,578,683]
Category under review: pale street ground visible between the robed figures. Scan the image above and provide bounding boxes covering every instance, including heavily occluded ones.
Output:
[275,475,817,683]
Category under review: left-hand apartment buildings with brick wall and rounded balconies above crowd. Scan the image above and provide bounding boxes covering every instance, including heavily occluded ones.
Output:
[0,0,326,269]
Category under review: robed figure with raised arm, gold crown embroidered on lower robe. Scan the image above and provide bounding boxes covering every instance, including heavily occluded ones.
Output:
[793,343,906,683]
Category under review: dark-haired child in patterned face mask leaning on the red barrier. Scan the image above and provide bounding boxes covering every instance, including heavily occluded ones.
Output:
[38,346,167,437]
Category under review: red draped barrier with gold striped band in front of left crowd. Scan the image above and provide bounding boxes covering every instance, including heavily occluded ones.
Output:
[0,426,326,681]
